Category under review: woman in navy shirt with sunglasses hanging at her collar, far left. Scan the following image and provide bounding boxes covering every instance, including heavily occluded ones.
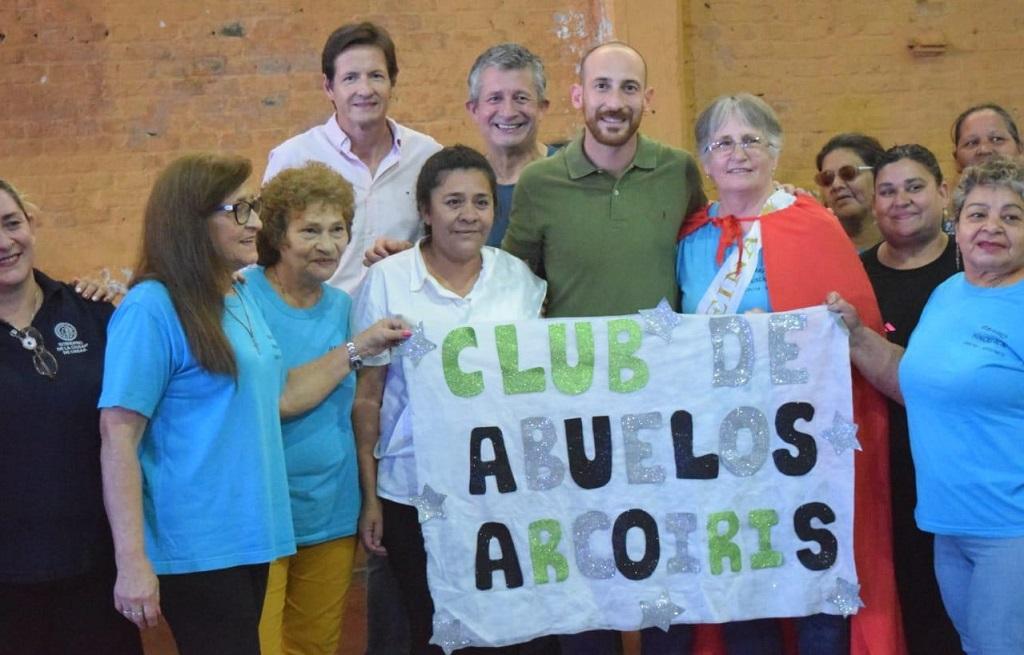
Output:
[0,180,142,655]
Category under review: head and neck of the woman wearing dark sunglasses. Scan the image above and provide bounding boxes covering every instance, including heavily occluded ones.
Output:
[814,132,885,251]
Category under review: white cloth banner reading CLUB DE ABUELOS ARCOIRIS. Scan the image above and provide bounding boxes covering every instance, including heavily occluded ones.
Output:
[402,305,857,650]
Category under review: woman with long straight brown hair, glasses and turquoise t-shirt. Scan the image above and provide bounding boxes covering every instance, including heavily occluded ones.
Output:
[98,155,400,655]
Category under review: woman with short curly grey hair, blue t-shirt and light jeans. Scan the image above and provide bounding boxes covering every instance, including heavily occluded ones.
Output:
[828,159,1024,654]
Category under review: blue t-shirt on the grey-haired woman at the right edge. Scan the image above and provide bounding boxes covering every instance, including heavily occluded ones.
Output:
[899,273,1024,537]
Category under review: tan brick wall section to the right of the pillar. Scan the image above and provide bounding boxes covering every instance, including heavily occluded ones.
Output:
[684,0,1024,188]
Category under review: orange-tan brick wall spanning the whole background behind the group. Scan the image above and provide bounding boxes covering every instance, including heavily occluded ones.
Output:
[0,0,1024,276]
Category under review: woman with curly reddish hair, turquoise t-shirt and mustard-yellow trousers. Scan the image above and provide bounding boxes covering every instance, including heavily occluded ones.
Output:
[253,163,401,655]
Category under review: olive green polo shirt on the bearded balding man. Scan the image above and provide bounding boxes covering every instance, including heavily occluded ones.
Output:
[502,134,707,317]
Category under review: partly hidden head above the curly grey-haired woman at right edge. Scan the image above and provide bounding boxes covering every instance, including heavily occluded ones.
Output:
[952,102,1024,173]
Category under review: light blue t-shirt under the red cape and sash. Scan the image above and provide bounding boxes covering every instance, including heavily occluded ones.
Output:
[676,203,772,314]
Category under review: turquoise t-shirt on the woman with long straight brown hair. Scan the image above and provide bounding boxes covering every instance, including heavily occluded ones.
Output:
[99,281,295,574]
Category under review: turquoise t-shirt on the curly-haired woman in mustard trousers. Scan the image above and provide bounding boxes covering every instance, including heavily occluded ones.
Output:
[246,268,359,545]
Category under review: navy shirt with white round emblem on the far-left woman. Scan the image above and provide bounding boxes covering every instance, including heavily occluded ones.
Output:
[0,271,114,582]
